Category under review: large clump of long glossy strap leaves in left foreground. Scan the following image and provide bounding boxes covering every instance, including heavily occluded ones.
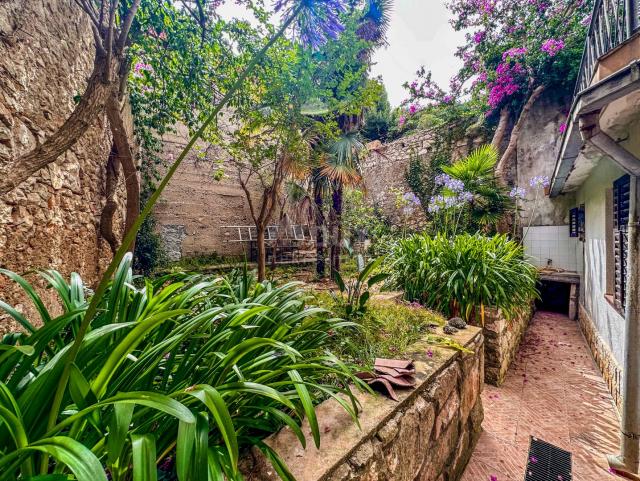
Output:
[0,254,360,481]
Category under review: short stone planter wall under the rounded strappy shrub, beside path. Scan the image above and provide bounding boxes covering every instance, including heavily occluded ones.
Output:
[483,308,533,386]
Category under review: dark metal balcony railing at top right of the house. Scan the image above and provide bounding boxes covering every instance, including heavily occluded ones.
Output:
[575,0,640,95]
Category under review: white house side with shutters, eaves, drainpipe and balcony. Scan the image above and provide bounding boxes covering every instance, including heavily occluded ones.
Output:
[549,0,640,473]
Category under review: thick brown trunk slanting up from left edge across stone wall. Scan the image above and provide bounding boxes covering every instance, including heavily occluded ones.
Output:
[0,58,114,195]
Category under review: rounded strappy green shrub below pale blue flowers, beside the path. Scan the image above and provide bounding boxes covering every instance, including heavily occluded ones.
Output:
[390,234,538,324]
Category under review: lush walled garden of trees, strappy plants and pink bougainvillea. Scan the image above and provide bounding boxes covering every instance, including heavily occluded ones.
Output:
[0,0,590,481]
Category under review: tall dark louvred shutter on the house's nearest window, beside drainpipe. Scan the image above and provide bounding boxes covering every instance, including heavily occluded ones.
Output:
[613,175,631,313]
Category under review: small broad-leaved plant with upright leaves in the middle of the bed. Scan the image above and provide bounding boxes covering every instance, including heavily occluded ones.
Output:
[334,240,389,319]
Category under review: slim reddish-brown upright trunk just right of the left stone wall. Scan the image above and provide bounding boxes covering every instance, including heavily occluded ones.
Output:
[106,91,140,252]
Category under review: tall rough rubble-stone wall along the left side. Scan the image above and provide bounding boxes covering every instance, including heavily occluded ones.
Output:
[0,0,121,334]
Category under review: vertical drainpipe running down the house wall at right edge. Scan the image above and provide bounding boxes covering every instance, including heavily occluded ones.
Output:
[609,176,640,479]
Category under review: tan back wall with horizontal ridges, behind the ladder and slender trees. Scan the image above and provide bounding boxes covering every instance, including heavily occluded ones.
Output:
[155,127,268,260]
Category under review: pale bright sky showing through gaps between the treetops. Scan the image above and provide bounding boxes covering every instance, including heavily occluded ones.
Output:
[219,0,464,107]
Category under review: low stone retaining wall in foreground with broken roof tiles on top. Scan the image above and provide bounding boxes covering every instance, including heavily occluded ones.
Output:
[242,327,484,481]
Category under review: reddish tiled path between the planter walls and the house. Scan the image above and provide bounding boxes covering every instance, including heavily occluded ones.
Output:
[462,312,620,481]
